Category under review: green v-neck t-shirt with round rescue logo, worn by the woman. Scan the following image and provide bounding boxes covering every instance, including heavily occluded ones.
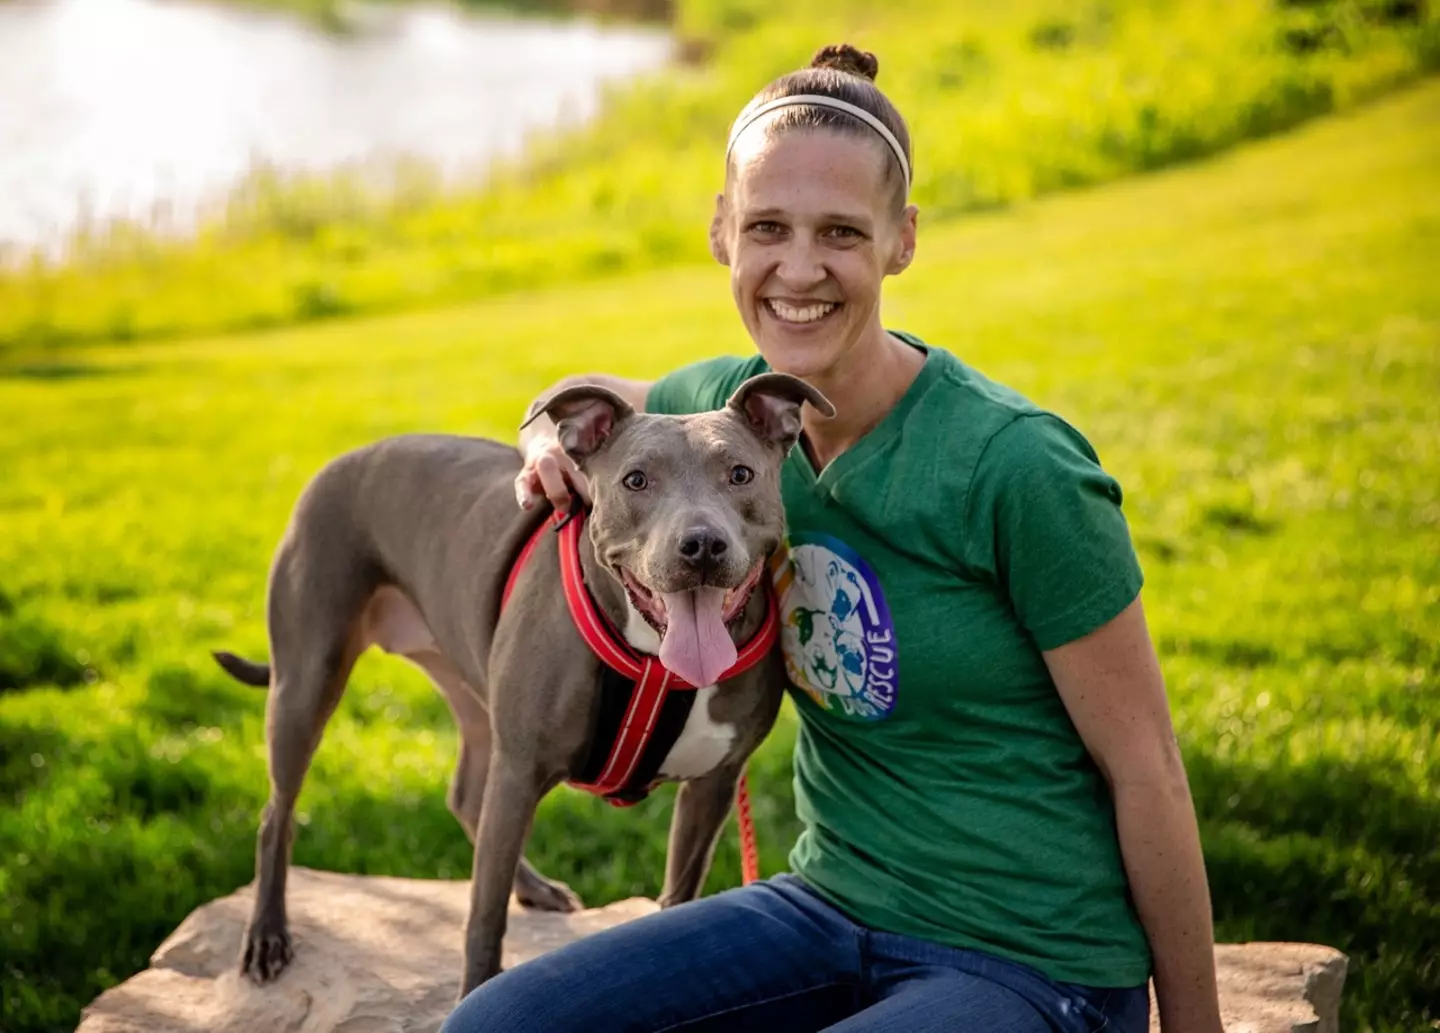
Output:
[647,334,1151,987]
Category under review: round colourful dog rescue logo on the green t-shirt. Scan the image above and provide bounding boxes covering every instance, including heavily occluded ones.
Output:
[775,535,896,720]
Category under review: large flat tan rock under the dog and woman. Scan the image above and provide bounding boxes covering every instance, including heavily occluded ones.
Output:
[79,867,1346,1033]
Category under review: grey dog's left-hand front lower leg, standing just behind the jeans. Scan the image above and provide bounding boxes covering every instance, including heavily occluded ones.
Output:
[459,749,549,998]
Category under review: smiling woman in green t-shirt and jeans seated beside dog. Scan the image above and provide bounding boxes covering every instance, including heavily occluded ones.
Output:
[445,46,1221,1033]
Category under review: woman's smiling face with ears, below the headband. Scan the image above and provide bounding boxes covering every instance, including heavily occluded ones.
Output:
[711,130,916,379]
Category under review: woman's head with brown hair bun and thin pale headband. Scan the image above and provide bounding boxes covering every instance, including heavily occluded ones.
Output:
[710,48,916,400]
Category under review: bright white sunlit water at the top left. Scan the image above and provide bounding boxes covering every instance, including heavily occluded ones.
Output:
[0,0,670,248]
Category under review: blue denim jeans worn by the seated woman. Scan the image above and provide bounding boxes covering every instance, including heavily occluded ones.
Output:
[441,875,1151,1033]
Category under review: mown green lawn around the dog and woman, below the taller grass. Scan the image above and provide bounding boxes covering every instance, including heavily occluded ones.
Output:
[0,82,1440,1033]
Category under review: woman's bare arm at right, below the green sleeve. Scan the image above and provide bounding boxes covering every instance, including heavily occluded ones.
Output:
[1044,599,1223,1033]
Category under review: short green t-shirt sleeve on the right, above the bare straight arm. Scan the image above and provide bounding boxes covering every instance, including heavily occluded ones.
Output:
[965,413,1143,650]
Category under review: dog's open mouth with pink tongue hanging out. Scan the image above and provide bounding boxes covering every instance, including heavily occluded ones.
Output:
[619,558,765,686]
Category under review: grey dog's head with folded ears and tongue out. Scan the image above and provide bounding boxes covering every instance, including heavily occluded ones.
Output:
[527,373,835,684]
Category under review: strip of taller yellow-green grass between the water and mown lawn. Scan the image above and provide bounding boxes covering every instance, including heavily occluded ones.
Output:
[0,0,1440,350]
